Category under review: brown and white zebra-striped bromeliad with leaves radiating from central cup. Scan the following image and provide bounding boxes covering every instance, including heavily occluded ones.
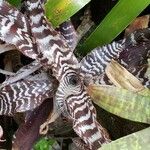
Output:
[0,0,150,150]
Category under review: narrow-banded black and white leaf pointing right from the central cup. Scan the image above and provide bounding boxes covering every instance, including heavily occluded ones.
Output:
[80,42,124,81]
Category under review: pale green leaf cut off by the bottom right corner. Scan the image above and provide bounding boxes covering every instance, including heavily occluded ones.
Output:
[99,128,150,150]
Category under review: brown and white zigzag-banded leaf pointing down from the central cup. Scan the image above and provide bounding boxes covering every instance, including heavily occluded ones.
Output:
[71,98,111,150]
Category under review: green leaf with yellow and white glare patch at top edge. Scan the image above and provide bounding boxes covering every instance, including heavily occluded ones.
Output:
[45,0,90,27]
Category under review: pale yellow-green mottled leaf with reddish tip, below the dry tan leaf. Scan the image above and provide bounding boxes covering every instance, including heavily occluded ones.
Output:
[88,85,150,124]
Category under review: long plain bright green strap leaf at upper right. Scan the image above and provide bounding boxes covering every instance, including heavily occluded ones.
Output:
[79,0,150,55]
